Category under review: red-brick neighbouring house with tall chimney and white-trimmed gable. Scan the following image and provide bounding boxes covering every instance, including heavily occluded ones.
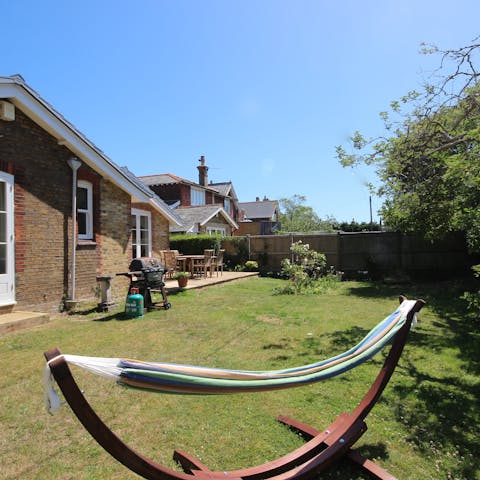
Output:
[139,155,239,236]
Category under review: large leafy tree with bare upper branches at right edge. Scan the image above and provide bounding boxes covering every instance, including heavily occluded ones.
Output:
[337,37,480,252]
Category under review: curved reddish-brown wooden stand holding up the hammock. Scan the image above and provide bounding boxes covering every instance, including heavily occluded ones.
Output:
[45,297,425,480]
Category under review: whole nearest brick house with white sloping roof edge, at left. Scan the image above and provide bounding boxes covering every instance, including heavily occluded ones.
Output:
[0,75,181,313]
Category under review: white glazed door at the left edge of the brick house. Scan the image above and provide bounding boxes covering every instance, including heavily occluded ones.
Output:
[0,172,15,306]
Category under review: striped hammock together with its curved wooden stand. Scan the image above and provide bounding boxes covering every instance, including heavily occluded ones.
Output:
[45,297,425,480]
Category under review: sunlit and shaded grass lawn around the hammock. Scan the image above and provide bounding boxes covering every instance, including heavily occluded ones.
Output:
[0,278,480,480]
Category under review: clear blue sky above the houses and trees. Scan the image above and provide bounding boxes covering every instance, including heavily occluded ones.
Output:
[0,0,480,221]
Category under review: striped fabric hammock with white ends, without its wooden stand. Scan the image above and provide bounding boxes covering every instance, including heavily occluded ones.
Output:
[45,300,415,411]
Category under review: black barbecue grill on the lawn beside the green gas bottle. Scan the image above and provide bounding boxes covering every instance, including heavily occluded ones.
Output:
[117,257,172,310]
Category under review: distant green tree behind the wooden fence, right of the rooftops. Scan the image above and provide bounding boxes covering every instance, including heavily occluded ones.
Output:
[277,195,333,233]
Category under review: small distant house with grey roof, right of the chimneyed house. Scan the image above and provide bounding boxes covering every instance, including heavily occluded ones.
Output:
[235,197,281,235]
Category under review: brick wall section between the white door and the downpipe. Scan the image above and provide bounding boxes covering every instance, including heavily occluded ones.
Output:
[0,105,72,310]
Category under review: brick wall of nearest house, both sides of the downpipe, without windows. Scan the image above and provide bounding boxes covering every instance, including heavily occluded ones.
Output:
[0,104,141,311]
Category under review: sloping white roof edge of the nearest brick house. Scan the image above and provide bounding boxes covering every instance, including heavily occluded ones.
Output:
[0,77,179,225]
